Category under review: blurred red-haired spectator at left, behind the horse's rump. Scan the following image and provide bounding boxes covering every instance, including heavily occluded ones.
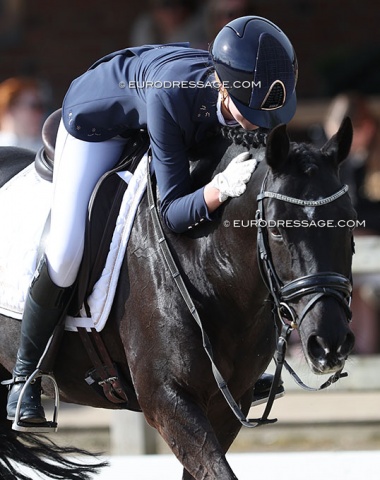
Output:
[0,77,47,151]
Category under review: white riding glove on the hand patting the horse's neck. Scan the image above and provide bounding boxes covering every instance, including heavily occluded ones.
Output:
[210,152,257,202]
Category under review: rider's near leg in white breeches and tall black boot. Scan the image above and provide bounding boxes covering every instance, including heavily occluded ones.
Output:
[7,125,125,423]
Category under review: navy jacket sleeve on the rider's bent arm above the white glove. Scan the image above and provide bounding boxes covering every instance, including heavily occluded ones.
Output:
[147,89,211,233]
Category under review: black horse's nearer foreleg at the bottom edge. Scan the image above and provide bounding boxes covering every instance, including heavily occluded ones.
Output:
[139,385,237,480]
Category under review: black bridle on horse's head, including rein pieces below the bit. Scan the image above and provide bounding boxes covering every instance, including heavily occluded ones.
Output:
[256,170,352,419]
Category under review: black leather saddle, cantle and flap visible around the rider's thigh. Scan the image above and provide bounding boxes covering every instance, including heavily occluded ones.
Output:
[35,109,149,316]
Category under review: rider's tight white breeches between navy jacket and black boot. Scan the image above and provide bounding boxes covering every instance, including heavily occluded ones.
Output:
[45,122,126,287]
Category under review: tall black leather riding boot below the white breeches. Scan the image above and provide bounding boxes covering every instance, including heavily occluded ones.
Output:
[7,259,70,423]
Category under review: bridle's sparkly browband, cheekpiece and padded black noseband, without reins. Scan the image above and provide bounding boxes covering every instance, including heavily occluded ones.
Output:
[256,173,352,329]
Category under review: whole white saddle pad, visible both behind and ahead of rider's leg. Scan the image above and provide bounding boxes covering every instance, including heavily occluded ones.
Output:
[0,155,147,331]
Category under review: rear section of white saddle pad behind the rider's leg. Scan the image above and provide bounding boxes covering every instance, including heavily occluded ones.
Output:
[0,163,53,319]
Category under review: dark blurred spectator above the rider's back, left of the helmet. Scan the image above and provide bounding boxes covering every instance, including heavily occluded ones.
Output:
[130,0,196,45]
